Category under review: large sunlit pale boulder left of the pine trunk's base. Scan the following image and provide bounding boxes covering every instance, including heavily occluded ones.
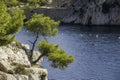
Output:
[0,45,31,71]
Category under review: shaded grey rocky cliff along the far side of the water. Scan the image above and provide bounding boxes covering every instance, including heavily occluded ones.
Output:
[29,0,120,25]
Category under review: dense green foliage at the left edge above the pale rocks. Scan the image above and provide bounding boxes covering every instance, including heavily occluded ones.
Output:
[0,0,25,46]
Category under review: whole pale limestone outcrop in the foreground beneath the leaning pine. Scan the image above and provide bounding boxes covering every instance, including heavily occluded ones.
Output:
[0,43,47,80]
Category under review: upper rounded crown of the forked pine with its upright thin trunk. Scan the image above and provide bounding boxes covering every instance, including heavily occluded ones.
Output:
[26,14,59,63]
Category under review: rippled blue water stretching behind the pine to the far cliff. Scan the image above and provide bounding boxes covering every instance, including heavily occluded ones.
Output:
[17,25,120,80]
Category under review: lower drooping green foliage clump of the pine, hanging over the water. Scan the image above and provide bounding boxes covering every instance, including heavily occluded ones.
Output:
[38,40,74,69]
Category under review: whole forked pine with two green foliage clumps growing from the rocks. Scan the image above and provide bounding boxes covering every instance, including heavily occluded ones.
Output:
[26,14,74,69]
